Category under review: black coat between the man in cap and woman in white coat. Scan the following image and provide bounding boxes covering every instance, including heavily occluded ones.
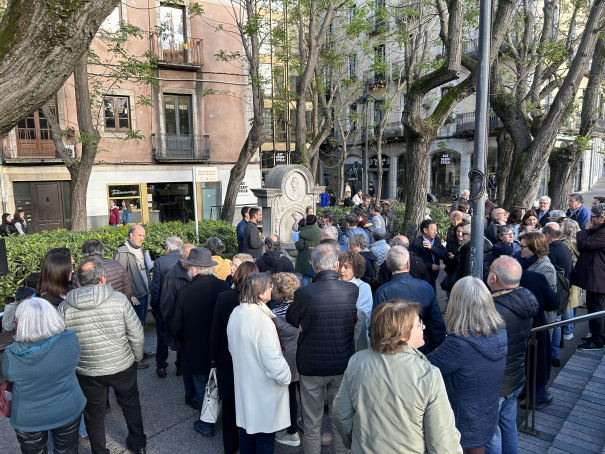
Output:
[210,289,239,402]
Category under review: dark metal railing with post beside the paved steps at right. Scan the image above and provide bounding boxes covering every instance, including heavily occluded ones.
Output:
[519,311,605,436]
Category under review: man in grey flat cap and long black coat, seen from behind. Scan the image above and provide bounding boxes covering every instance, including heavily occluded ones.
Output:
[168,247,230,437]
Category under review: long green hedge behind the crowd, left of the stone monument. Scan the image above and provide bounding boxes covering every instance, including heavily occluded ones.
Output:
[0,220,237,308]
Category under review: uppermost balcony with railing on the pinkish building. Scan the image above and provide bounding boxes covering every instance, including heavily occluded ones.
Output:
[151,35,204,71]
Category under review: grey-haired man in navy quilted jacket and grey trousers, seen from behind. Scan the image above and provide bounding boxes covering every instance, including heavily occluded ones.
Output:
[286,244,359,454]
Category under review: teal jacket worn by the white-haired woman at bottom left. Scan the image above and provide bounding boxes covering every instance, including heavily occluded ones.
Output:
[2,331,86,432]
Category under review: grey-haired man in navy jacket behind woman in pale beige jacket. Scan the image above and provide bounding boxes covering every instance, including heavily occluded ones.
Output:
[372,246,445,355]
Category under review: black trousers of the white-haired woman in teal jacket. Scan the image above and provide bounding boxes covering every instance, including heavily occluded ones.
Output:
[15,415,81,454]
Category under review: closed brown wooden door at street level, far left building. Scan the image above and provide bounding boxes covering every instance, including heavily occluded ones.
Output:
[32,181,65,233]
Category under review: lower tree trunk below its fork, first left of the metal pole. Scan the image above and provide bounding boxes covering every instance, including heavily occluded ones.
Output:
[403,136,436,238]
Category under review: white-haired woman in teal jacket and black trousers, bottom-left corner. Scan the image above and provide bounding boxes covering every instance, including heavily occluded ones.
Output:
[2,297,86,452]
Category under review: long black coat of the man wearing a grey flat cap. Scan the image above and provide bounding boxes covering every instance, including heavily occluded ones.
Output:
[168,274,229,375]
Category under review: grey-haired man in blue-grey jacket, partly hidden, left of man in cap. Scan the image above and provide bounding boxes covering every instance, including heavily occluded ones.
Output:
[150,236,183,378]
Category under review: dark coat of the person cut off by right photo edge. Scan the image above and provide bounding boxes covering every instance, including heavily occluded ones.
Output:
[570,224,605,293]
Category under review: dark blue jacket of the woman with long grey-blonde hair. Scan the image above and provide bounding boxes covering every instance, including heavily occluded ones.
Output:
[427,328,508,449]
